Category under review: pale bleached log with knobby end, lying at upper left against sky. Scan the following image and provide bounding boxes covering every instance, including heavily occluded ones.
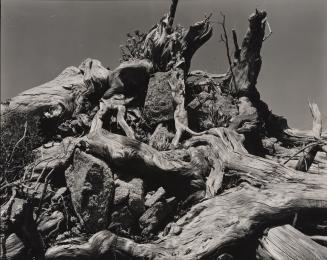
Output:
[4,59,109,119]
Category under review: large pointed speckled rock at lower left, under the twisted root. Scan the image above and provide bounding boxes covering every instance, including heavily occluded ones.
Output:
[65,149,114,233]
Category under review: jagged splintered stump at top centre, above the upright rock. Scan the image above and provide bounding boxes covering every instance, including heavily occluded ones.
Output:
[143,0,212,74]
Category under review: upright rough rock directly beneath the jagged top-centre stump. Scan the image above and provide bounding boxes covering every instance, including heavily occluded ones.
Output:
[144,72,174,127]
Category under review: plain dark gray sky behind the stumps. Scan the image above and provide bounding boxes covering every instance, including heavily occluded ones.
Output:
[1,0,327,128]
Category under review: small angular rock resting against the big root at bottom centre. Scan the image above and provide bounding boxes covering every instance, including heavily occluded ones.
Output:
[139,197,176,234]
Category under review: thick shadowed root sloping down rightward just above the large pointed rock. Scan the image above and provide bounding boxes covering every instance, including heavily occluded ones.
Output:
[86,108,209,198]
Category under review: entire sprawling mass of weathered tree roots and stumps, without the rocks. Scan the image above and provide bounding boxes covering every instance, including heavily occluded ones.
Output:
[2,0,327,260]
